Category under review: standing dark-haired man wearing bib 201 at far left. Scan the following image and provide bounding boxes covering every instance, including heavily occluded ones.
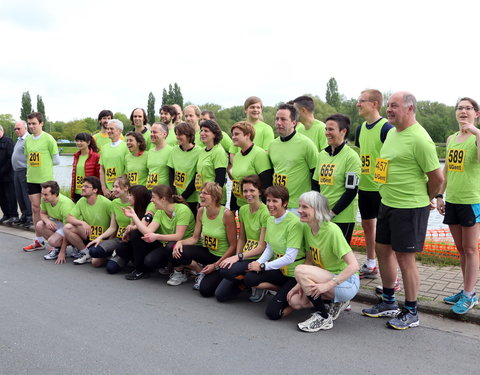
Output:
[23,112,60,251]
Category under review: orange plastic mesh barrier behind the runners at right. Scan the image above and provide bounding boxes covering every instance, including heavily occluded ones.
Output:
[350,229,480,259]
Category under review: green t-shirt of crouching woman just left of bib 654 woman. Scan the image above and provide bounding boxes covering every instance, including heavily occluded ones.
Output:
[153,203,195,240]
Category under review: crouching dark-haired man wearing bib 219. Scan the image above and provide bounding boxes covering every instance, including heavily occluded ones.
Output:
[63,176,112,264]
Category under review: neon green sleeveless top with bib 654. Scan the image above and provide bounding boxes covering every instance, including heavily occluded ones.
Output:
[202,206,230,257]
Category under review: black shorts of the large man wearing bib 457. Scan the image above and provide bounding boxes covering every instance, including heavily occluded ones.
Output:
[375,204,430,253]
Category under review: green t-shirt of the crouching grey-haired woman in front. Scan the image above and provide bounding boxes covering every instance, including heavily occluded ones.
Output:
[302,221,352,274]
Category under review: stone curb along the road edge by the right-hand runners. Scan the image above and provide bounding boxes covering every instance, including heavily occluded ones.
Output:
[353,288,480,325]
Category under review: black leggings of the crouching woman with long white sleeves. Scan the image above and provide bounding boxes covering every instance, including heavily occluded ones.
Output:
[244,270,297,320]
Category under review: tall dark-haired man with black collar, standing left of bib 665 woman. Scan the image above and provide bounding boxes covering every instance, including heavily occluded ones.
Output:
[268,104,318,212]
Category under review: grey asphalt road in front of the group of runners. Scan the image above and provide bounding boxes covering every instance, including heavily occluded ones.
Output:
[0,233,480,375]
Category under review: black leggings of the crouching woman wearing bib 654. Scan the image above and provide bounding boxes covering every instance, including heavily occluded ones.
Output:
[172,245,222,297]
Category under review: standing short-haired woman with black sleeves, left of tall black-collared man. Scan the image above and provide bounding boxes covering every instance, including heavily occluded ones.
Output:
[230,121,273,211]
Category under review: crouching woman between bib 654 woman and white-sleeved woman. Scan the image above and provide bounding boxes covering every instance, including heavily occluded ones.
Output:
[215,176,270,302]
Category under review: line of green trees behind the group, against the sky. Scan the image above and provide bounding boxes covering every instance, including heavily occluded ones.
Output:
[0,77,458,143]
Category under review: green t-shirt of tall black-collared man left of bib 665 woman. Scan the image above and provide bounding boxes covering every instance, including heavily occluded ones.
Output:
[268,133,318,208]
